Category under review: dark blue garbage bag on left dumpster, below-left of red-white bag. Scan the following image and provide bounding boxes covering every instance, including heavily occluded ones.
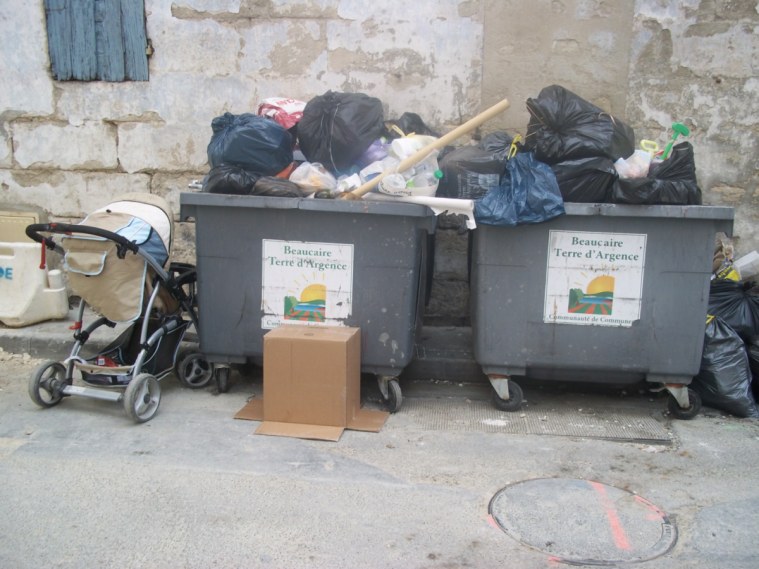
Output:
[208,113,293,176]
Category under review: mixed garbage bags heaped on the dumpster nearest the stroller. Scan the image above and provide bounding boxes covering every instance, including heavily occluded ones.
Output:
[203,91,442,197]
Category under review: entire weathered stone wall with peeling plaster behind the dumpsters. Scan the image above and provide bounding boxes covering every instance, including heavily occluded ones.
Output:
[0,0,759,323]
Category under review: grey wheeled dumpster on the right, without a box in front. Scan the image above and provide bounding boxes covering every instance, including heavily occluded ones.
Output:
[470,203,733,418]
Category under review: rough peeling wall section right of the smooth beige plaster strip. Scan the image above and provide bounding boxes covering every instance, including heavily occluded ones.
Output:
[626,0,759,254]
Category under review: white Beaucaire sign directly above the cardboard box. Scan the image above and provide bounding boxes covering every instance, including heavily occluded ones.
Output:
[261,239,353,330]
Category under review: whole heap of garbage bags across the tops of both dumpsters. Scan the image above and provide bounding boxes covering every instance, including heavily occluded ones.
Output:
[203,85,701,226]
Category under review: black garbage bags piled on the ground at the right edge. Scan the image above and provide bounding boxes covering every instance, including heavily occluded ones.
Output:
[691,235,759,418]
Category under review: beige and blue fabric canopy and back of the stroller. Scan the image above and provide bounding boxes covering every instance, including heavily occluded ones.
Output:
[61,194,173,322]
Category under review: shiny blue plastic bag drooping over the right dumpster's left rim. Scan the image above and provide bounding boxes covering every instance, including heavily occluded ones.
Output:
[474,152,564,226]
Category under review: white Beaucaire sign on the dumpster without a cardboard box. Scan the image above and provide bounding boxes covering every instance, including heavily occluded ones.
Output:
[543,231,646,327]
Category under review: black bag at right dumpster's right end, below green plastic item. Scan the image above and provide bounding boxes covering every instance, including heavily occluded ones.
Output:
[612,142,701,205]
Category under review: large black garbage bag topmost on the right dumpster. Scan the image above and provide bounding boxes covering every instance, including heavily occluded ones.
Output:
[525,85,635,164]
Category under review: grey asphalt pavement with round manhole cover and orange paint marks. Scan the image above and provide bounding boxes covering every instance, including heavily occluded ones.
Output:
[0,316,759,569]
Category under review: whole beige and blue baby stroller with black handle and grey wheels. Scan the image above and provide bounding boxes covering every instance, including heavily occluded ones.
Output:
[26,193,214,423]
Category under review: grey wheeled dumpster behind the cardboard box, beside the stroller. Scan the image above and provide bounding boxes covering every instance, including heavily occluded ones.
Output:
[180,192,435,411]
